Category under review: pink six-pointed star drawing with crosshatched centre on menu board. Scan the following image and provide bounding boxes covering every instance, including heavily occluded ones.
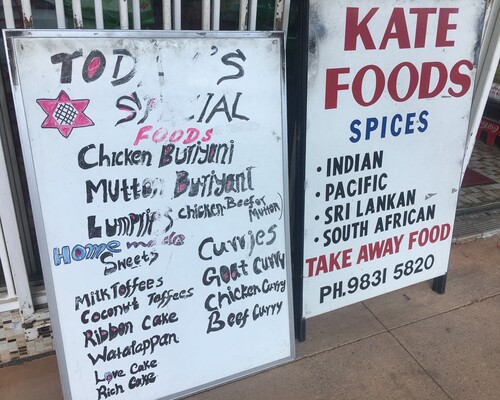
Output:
[36,90,94,138]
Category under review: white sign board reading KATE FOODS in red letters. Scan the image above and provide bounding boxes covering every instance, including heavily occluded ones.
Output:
[303,0,484,317]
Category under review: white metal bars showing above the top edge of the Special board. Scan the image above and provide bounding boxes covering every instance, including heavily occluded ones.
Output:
[1,0,290,30]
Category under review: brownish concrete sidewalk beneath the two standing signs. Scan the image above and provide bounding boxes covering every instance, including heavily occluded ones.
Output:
[0,236,500,400]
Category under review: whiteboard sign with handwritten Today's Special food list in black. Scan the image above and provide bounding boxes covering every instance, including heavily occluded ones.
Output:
[6,31,294,400]
